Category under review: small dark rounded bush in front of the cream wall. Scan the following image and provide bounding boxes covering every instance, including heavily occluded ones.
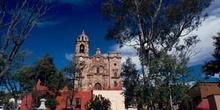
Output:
[85,94,111,110]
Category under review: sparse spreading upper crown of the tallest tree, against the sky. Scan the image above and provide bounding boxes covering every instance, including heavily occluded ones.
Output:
[101,0,212,55]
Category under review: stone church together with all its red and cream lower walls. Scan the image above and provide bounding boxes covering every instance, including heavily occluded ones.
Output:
[21,31,125,110]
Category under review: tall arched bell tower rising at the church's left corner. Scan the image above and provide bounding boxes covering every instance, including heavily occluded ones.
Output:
[75,30,89,57]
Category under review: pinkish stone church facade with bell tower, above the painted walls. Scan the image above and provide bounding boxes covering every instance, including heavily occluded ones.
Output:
[74,31,121,90]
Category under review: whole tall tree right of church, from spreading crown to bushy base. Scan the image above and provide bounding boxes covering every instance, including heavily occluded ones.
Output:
[101,0,212,109]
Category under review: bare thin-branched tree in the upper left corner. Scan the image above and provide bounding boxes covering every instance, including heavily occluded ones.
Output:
[0,0,52,78]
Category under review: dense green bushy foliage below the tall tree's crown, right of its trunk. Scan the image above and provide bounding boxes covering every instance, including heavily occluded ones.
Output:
[149,54,189,107]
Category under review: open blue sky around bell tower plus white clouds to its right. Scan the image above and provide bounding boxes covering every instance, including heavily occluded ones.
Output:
[22,0,220,80]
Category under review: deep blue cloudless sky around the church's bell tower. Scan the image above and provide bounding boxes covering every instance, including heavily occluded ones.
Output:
[23,0,115,68]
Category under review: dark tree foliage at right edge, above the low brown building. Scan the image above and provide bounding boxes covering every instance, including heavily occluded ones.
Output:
[202,32,220,77]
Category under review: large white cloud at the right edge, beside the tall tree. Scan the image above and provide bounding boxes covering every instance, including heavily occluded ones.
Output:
[190,16,220,65]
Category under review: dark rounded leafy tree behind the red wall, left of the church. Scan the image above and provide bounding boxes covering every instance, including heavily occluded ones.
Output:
[34,54,66,93]
